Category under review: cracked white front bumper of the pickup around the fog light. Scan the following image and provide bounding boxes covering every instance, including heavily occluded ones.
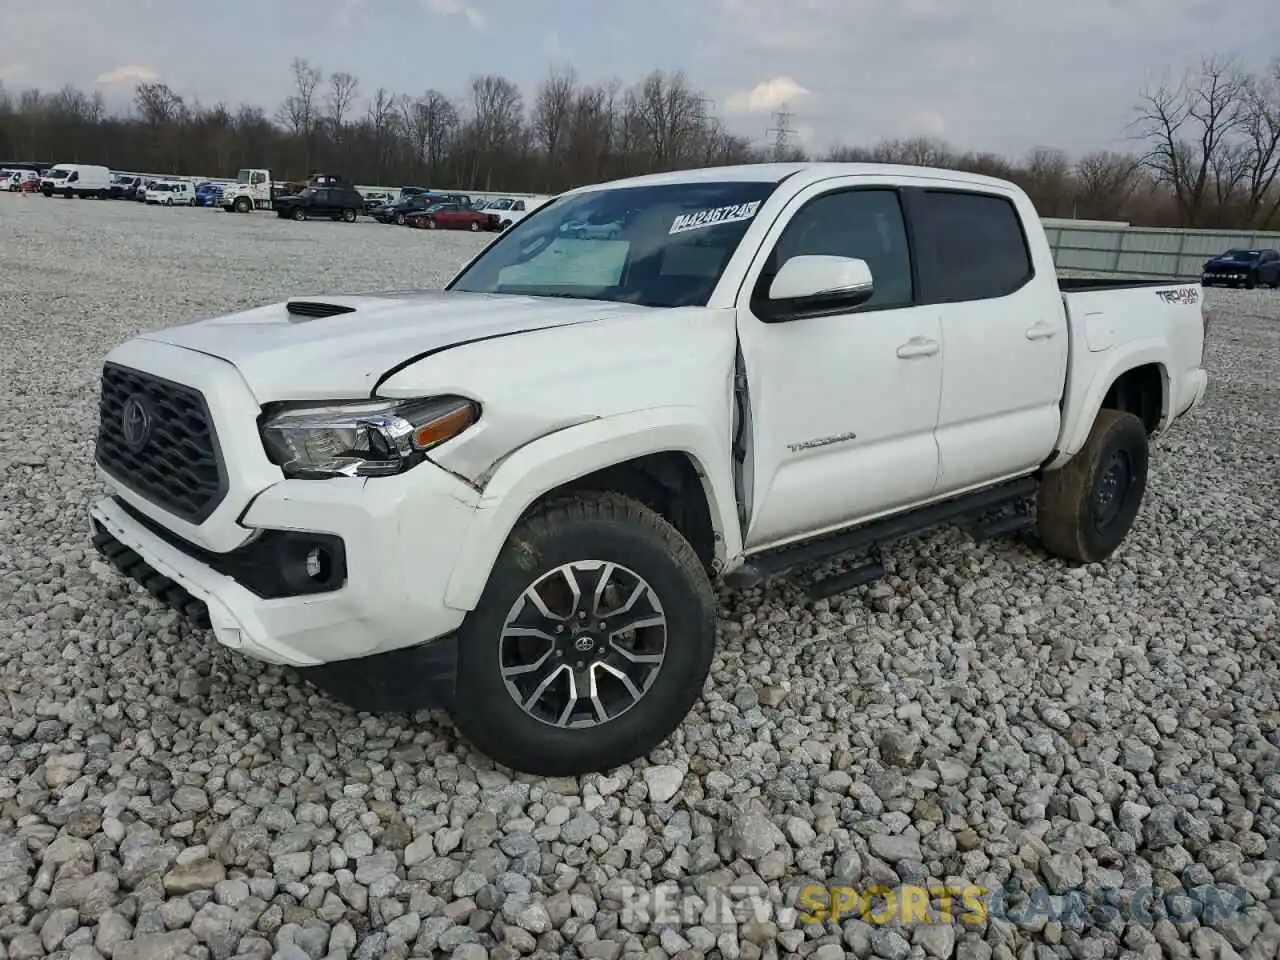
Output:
[90,450,477,669]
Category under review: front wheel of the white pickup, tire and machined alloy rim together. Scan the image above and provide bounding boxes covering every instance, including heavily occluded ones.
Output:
[449,493,716,776]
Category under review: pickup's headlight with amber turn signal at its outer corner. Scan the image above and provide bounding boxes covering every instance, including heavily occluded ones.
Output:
[262,397,480,479]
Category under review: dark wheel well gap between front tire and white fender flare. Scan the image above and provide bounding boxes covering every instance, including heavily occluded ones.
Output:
[521,449,724,575]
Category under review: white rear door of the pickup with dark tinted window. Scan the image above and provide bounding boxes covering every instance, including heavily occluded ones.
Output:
[908,187,1068,495]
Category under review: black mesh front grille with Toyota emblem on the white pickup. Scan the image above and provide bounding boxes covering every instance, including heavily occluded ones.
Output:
[97,364,227,524]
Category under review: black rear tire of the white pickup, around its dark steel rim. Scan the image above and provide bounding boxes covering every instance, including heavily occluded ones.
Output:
[1036,410,1149,563]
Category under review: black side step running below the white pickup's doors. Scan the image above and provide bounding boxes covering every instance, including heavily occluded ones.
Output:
[724,476,1039,596]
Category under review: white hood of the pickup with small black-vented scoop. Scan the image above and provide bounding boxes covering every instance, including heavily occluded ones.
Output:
[142,291,652,403]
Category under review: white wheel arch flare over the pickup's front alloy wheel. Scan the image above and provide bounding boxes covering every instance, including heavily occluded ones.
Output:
[445,407,741,611]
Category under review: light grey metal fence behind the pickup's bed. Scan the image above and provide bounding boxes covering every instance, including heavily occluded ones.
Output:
[1043,219,1280,280]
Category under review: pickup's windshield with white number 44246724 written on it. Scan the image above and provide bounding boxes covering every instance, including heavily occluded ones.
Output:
[448,182,777,307]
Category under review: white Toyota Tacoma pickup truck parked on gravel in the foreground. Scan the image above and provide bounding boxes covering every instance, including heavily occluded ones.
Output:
[91,164,1206,774]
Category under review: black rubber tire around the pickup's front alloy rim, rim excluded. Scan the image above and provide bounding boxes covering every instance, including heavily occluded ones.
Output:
[449,493,716,776]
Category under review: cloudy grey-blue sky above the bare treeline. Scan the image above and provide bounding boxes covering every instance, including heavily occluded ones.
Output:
[0,0,1280,156]
